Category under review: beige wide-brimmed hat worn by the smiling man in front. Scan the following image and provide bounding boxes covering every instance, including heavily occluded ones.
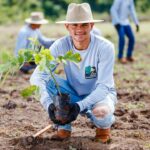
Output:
[56,3,104,24]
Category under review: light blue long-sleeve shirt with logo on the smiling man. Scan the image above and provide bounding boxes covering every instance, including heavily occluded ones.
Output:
[30,34,116,111]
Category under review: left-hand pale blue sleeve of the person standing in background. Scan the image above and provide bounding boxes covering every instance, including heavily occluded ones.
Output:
[110,0,121,24]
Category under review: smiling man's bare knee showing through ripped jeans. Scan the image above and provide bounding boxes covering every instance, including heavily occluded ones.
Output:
[92,105,111,119]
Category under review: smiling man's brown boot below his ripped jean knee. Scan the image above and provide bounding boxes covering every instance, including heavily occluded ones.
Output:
[95,128,110,143]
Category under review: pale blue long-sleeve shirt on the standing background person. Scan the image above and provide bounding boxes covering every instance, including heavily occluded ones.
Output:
[110,0,139,25]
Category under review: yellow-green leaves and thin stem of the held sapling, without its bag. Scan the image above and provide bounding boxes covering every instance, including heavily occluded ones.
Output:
[0,38,81,97]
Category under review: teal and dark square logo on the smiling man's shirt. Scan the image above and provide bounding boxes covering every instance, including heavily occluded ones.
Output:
[85,66,97,79]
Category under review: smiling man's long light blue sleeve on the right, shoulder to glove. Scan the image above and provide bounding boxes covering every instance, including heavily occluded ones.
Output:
[77,44,115,111]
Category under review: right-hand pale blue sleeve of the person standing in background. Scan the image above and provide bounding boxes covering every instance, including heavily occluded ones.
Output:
[130,0,139,25]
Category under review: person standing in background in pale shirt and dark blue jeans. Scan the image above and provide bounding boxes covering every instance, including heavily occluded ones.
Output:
[110,0,139,64]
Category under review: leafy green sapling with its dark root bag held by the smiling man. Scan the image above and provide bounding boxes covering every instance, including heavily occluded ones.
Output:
[0,38,81,120]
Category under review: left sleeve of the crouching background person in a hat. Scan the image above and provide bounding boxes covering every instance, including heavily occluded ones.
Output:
[15,31,28,56]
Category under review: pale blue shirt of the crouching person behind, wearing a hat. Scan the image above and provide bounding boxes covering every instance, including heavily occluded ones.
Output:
[15,25,54,56]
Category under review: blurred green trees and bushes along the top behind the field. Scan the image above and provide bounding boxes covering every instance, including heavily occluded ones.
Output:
[0,0,150,24]
